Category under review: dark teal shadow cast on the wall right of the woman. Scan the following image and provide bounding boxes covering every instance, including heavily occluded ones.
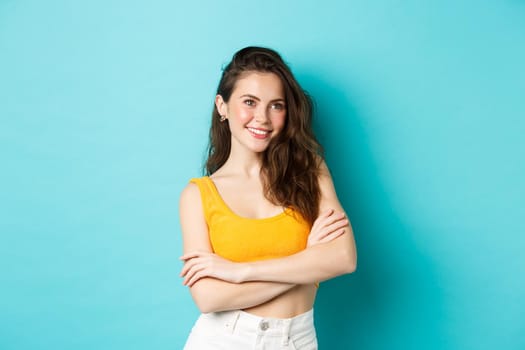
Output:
[299,75,448,350]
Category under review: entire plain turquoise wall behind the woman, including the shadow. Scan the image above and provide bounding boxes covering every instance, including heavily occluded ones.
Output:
[0,0,525,350]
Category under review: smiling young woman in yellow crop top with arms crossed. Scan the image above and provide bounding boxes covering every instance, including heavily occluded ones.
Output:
[180,47,356,350]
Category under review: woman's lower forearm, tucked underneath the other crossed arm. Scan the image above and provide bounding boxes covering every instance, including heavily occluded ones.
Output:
[190,278,295,313]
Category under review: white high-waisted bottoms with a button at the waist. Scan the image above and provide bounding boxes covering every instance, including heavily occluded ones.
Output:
[184,309,317,350]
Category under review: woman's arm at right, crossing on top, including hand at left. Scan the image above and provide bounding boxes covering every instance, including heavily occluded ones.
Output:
[181,163,357,286]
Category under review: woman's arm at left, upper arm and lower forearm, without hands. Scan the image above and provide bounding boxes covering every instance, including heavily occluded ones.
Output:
[180,184,294,313]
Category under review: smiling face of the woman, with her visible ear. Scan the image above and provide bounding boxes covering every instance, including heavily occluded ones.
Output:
[215,72,286,153]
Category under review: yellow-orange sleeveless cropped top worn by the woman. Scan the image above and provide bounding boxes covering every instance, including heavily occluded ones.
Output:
[190,176,310,262]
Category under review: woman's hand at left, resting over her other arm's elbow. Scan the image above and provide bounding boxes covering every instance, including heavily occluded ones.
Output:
[180,252,243,287]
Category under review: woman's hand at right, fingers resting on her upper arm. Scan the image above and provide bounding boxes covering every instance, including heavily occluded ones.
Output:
[306,209,349,247]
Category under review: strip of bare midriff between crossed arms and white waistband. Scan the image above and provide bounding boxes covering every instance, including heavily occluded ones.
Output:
[243,284,317,318]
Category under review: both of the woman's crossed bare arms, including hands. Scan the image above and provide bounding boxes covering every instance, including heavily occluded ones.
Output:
[180,164,357,313]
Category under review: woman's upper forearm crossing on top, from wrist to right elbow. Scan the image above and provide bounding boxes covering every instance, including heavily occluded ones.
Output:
[243,234,356,284]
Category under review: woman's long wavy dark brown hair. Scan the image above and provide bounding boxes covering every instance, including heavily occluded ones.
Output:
[205,47,324,224]
